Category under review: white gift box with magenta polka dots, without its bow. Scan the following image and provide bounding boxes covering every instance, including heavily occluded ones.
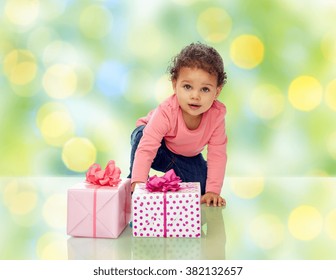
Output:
[132,182,201,238]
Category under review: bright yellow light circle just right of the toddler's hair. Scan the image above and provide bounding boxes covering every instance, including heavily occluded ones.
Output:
[230,34,264,69]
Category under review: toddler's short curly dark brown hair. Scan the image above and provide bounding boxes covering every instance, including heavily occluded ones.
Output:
[168,43,227,86]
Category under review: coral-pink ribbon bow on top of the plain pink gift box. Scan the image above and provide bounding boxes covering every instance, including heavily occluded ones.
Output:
[86,160,121,187]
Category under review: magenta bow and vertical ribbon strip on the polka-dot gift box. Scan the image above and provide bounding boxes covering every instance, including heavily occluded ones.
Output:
[146,169,182,237]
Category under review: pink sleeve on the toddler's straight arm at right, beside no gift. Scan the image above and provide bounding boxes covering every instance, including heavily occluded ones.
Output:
[206,112,227,194]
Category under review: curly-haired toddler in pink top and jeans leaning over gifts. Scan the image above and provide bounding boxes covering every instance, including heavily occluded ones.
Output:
[129,43,227,206]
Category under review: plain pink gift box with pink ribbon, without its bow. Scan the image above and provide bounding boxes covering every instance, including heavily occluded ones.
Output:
[67,179,131,238]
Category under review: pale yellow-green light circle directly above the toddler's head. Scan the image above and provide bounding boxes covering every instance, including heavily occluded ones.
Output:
[197,7,232,43]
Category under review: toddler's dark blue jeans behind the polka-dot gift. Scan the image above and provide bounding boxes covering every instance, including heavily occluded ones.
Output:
[128,125,208,195]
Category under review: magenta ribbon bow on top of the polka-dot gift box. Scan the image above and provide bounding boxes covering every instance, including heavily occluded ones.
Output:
[146,169,182,192]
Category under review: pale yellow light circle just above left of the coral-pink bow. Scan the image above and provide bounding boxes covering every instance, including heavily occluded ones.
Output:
[62,137,97,172]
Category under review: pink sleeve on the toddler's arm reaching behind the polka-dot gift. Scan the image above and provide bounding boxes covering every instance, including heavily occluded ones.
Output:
[131,106,169,183]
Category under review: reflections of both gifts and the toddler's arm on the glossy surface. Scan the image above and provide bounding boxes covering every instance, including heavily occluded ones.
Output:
[67,207,226,260]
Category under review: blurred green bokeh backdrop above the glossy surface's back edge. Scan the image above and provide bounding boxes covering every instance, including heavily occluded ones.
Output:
[0,0,336,176]
